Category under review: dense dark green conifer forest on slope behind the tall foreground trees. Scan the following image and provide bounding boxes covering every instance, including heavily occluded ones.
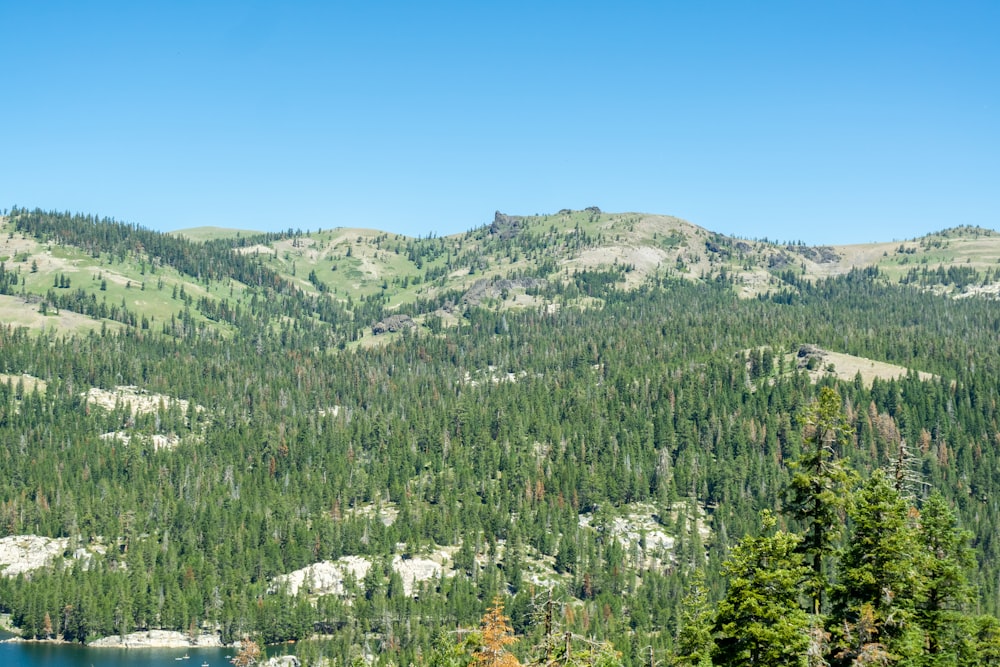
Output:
[0,214,1000,664]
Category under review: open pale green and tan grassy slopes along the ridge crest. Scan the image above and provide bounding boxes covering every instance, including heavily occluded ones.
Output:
[0,211,1000,342]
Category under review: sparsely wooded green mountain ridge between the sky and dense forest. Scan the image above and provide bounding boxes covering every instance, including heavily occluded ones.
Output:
[0,208,1000,343]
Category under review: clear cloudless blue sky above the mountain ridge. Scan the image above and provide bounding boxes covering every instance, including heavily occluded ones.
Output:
[0,0,1000,243]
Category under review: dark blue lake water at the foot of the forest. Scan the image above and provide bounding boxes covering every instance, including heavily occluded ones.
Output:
[0,632,278,667]
